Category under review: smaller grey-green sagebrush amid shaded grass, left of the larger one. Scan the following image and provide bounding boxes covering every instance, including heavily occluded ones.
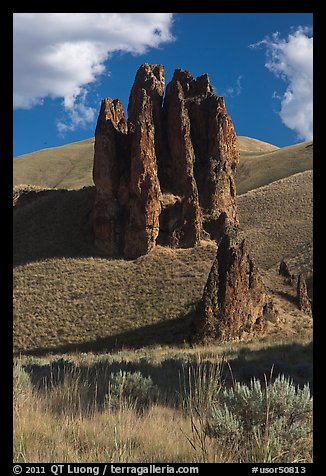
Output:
[106,370,158,409]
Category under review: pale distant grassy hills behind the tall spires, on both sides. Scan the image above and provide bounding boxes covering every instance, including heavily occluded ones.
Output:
[13,136,312,194]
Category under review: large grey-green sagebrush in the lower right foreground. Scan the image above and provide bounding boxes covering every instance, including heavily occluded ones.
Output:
[206,376,312,462]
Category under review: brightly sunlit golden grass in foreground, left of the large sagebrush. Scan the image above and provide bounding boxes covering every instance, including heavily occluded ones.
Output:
[14,374,229,463]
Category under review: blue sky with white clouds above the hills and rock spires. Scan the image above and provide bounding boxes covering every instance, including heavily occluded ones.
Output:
[14,13,313,156]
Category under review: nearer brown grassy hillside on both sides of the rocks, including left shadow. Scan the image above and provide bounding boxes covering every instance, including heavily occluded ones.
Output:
[14,171,312,351]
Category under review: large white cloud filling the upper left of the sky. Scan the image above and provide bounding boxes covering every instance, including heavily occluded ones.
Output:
[13,13,173,132]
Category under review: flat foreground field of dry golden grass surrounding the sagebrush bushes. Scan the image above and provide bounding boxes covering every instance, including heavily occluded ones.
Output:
[14,341,312,463]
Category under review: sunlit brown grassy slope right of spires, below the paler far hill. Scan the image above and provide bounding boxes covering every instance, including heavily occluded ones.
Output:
[237,171,313,269]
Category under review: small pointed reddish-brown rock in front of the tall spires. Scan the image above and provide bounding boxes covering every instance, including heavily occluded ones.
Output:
[192,234,275,344]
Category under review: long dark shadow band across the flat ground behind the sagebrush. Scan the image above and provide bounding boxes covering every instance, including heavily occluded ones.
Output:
[24,344,312,408]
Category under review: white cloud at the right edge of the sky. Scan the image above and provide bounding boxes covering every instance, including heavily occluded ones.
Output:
[250,27,313,140]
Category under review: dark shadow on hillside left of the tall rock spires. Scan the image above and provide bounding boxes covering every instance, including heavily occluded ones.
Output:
[13,187,102,265]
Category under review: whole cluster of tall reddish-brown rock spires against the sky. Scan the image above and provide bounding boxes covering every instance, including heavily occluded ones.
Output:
[92,64,240,258]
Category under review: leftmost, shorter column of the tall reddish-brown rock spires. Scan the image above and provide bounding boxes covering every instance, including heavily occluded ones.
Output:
[92,98,130,256]
